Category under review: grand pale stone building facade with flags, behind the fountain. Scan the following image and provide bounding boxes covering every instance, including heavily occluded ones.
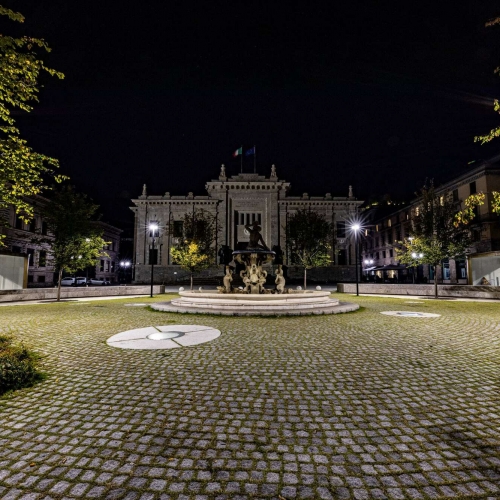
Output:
[131,165,363,283]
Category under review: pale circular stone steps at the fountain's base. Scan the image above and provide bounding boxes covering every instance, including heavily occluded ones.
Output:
[151,290,359,316]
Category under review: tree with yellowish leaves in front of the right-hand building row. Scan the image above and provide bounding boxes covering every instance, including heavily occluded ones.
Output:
[396,184,485,298]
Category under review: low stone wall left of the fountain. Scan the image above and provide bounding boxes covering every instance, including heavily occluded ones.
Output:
[0,285,165,302]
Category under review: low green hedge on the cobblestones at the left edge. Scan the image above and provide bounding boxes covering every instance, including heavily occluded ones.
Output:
[0,335,45,395]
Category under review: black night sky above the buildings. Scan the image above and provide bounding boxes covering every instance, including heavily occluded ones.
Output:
[2,0,500,227]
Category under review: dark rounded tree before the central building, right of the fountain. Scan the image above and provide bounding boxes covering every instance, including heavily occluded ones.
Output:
[286,209,332,290]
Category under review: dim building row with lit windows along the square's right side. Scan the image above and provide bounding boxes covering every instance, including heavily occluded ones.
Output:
[362,155,500,286]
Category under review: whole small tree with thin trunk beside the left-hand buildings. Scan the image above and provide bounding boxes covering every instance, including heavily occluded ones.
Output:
[38,187,107,301]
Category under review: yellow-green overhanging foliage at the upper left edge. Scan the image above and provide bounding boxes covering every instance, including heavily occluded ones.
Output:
[0,6,66,244]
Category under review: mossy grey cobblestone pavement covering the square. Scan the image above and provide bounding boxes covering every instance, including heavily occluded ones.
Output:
[0,296,500,500]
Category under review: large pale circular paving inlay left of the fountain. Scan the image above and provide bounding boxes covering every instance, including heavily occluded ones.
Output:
[106,325,220,349]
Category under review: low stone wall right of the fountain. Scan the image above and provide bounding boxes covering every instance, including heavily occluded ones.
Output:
[337,283,500,299]
